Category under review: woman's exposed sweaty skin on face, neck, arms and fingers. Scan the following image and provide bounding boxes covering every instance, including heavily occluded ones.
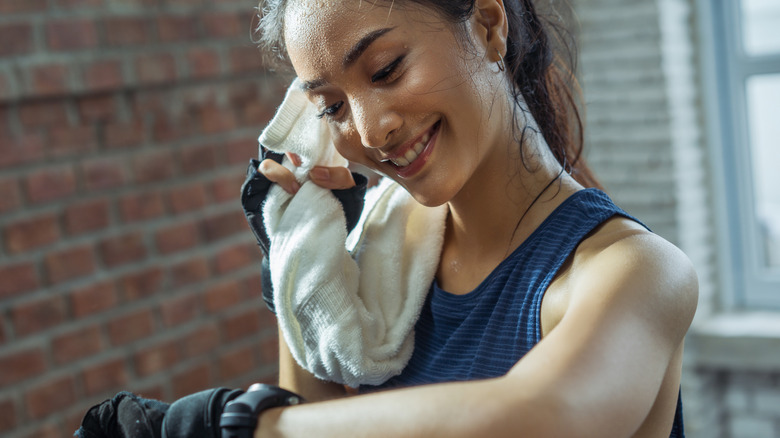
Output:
[255,0,697,438]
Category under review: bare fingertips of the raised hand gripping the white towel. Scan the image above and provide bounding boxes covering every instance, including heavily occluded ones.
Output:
[257,152,355,194]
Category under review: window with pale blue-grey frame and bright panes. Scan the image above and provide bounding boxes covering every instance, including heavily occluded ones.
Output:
[700,0,780,309]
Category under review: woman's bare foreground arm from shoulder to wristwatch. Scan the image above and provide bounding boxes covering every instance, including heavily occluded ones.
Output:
[255,235,697,438]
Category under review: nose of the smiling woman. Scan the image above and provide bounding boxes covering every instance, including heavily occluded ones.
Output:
[352,100,403,148]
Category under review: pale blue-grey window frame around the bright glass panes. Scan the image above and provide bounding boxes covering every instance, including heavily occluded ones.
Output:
[697,0,780,309]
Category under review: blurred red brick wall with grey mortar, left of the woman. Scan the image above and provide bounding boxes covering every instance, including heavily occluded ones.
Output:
[0,0,284,438]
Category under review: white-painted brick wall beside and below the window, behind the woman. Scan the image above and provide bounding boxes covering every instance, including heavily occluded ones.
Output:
[573,0,780,438]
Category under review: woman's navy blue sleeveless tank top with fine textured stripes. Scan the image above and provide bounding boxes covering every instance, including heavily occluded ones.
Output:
[361,189,684,438]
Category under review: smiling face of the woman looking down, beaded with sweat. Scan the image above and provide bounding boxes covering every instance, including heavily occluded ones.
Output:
[284,0,508,205]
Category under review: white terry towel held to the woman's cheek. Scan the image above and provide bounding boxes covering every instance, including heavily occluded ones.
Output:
[258,79,447,387]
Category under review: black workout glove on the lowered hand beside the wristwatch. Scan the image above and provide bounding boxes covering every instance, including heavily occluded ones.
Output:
[74,388,244,438]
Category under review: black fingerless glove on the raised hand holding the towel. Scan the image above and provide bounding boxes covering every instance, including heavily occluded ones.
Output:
[241,150,368,313]
